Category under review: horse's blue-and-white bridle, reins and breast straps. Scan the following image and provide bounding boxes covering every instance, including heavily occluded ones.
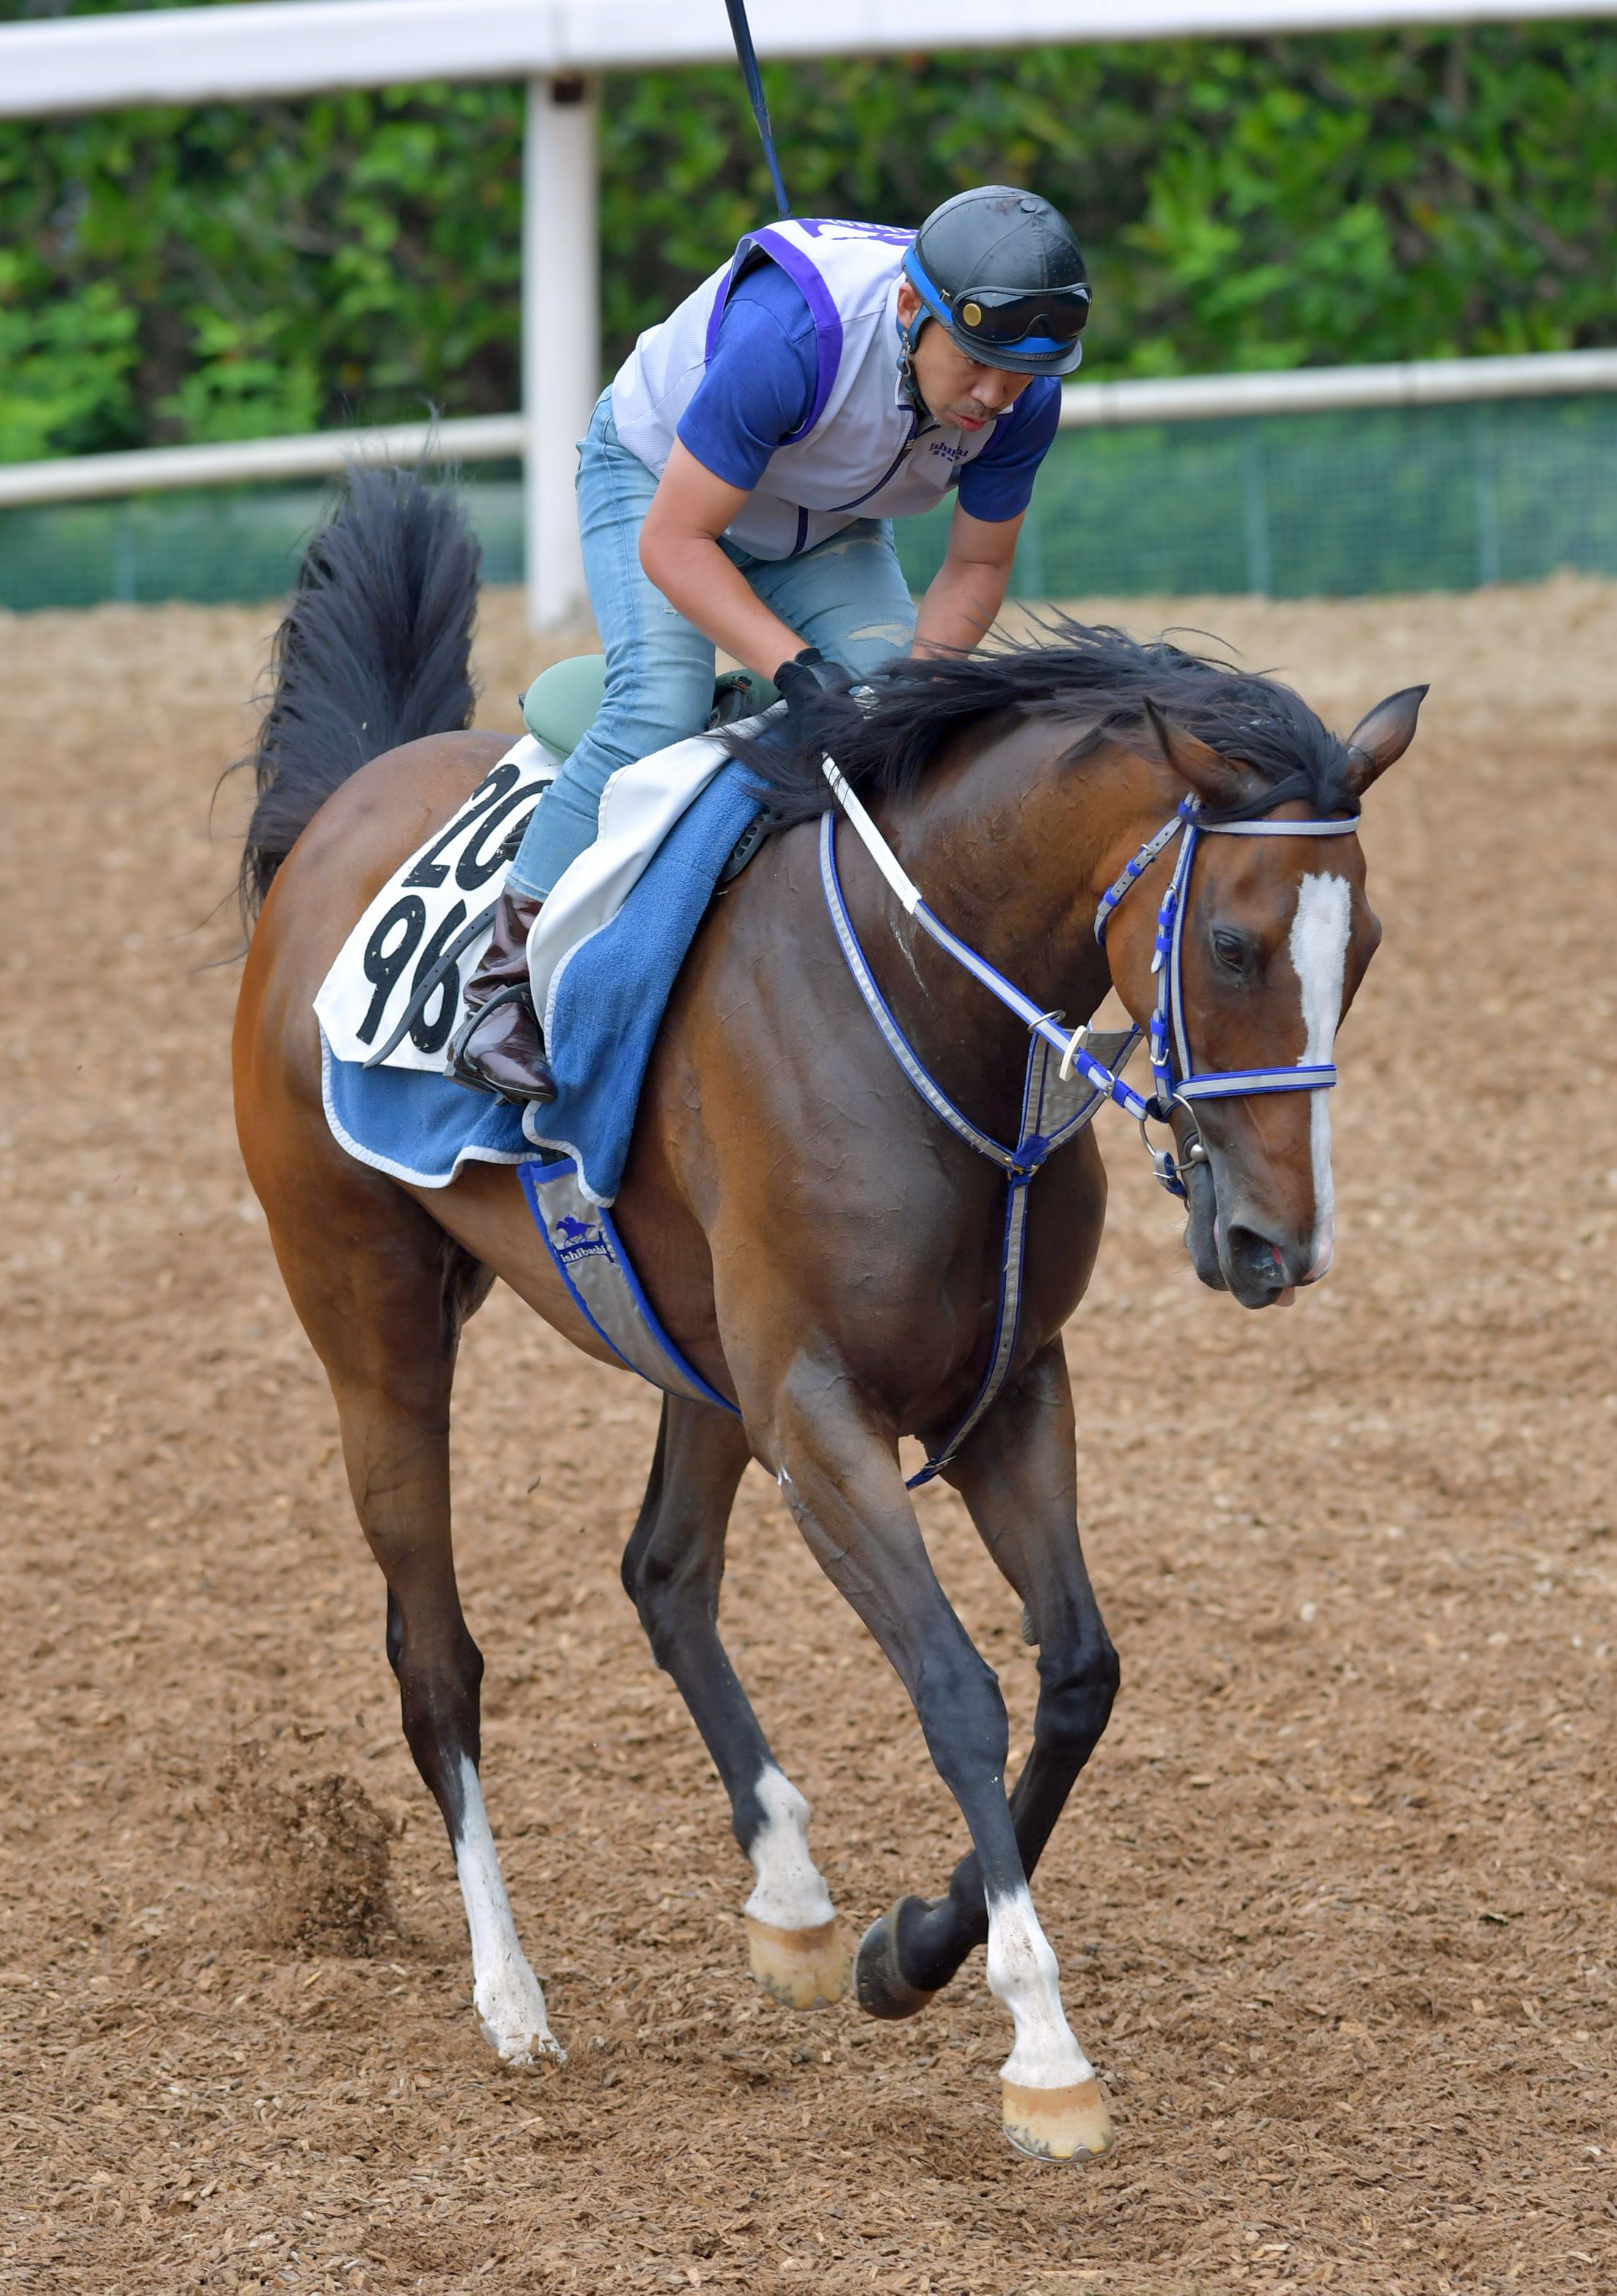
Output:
[820,758,1357,1488]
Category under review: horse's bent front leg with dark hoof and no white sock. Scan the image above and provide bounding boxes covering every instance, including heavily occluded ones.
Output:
[857,1339,1118,2016]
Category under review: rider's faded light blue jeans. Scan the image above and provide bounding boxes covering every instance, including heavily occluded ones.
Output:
[505,390,914,900]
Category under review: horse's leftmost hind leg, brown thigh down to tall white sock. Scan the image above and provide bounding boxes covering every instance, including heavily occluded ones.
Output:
[253,1144,562,2064]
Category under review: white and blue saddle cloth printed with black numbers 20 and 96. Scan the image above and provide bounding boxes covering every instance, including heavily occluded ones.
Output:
[315,735,758,1205]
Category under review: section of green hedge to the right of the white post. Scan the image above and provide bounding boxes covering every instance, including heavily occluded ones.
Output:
[602,23,1617,374]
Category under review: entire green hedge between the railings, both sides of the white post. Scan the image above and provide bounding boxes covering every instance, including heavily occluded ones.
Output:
[0,0,1617,459]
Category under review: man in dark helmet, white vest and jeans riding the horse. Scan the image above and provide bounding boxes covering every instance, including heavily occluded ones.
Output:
[452,183,1089,1102]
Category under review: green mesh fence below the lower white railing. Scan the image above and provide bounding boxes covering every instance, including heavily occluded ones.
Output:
[0,395,1617,611]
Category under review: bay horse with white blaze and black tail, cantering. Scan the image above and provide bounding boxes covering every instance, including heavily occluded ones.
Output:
[234,471,1426,2160]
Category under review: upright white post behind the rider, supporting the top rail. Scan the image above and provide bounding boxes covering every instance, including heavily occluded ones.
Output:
[521,78,602,629]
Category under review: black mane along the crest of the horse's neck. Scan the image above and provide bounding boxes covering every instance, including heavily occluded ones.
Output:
[730,613,1357,829]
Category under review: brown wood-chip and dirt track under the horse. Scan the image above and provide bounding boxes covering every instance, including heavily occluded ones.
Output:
[0,581,1617,2296]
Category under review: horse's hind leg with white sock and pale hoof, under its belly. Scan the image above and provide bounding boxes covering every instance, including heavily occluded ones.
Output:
[623,1396,848,2009]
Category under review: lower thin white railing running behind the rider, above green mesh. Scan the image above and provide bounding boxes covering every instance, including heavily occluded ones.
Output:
[0,351,1617,510]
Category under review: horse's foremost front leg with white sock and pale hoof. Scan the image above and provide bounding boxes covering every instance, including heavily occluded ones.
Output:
[774,1361,1112,2160]
